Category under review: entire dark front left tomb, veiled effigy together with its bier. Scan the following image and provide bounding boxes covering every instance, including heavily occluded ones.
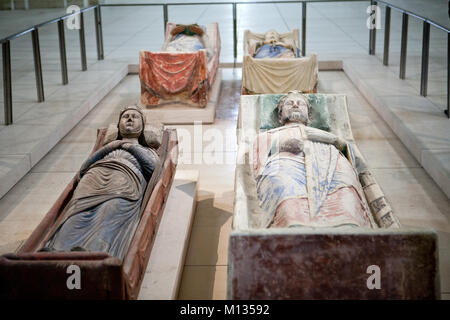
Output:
[0,107,178,299]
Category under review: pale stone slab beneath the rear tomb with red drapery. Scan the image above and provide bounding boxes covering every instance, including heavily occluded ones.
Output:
[141,69,222,124]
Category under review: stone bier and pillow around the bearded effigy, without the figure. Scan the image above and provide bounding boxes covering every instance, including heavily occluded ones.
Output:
[228,94,440,299]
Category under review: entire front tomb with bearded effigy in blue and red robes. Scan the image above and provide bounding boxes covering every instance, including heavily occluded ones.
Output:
[228,92,440,299]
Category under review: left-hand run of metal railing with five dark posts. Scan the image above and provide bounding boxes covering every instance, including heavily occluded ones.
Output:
[0,5,104,125]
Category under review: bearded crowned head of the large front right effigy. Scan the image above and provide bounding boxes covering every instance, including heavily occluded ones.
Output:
[277,90,311,126]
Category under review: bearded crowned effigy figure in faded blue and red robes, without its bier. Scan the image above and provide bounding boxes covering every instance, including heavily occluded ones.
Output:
[253,91,377,228]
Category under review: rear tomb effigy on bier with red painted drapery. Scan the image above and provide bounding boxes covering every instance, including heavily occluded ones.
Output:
[139,23,220,108]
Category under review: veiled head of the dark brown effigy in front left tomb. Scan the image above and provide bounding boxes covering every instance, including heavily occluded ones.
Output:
[117,106,146,144]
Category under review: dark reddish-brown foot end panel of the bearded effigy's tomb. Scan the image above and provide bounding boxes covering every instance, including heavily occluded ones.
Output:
[228,228,440,300]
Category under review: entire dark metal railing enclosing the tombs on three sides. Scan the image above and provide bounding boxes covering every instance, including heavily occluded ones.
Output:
[0,0,450,125]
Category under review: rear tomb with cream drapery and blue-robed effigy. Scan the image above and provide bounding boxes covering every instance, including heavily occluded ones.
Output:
[242,29,319,94]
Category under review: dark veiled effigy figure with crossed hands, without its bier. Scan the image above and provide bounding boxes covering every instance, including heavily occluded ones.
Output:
[42,106,160,258]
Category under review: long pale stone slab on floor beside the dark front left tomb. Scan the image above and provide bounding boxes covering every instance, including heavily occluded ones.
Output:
[138,170,199,300]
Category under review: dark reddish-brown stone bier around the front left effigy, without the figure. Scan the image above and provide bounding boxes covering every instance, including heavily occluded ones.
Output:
[0,128,178,299]
